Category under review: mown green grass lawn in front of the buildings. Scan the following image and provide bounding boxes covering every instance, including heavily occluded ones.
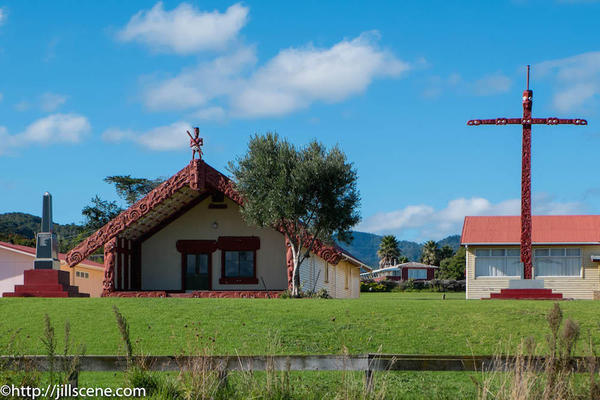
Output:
[0,292,600,399]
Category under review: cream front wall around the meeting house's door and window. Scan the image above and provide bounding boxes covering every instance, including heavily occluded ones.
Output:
[142,199,287,290]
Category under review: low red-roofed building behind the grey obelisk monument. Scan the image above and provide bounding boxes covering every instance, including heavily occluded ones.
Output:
[0,242,104,297]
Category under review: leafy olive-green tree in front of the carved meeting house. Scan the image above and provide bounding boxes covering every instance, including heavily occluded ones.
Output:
[229,133,360,296]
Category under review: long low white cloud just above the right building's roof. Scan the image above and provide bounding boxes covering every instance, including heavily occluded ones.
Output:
[356,194,587,240]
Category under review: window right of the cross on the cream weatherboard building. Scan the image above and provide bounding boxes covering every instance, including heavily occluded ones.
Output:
[533,247,582,276]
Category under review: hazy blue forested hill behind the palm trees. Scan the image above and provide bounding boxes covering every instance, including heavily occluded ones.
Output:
[339,231,460,267]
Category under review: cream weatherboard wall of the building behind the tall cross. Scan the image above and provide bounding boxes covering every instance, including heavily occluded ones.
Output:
[466,245,600,299]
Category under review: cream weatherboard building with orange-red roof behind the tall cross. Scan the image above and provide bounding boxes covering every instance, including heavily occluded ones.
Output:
[461,215,600,299]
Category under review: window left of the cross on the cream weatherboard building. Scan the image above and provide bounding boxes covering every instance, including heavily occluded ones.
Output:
[475,249,523,277]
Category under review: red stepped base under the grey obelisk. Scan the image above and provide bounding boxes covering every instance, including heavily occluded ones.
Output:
[3,269,90,297]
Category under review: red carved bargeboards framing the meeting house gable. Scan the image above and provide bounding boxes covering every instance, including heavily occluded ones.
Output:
[66,160,341,297]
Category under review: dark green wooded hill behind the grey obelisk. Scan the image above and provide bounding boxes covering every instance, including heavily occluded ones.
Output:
[0,212,85,252]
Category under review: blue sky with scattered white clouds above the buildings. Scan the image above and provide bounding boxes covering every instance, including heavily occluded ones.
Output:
[0,0,600,241]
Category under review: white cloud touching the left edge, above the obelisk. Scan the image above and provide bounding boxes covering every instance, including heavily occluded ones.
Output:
[0,114,91,154]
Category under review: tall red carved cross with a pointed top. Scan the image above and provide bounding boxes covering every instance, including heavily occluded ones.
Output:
[467,65,587,279]
